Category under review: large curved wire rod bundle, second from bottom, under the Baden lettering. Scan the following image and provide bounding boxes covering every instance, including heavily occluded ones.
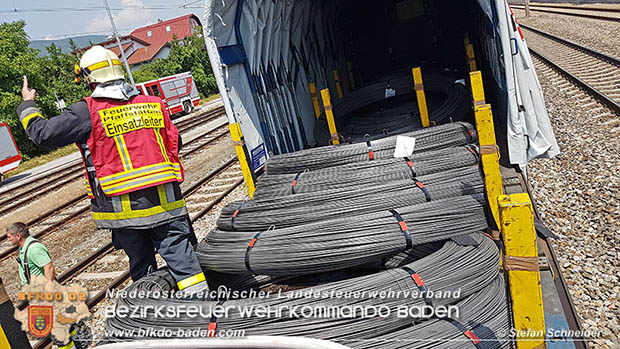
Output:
[106,234,504,345]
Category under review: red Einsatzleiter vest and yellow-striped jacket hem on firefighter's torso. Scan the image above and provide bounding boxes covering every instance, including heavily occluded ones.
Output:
[78,96,187,229]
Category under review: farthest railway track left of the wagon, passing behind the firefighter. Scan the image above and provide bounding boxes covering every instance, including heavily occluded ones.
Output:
[0,107,224,216]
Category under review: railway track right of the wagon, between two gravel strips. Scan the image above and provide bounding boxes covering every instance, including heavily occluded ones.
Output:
[521,25,620,115]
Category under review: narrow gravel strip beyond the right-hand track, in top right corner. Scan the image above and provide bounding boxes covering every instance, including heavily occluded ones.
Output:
[513,4,620,57]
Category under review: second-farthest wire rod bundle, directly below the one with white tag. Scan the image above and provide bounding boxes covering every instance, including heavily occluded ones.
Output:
[254,146,479,199]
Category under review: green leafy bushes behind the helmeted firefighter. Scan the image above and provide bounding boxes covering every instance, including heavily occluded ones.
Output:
[0,21,217,159]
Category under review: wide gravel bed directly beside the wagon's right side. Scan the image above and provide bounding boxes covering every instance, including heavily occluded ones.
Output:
[528,59,620,348]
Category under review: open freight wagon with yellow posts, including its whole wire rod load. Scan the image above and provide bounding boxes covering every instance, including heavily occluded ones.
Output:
[95,0,587,348]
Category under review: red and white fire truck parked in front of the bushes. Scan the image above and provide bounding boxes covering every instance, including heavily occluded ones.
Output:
[136,72,200,115]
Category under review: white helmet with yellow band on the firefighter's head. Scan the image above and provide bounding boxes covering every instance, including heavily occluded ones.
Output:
[75,45,125,85]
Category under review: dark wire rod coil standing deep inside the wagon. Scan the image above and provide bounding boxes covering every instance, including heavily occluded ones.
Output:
[314,72,471,145]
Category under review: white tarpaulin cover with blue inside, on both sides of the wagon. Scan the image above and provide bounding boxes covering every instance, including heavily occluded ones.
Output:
[204,0,559,169]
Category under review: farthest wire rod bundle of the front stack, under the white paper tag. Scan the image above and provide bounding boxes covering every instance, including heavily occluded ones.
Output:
[266,122,476,174]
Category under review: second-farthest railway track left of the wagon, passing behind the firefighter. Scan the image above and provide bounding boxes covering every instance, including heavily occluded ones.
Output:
[0,118,228,260]
